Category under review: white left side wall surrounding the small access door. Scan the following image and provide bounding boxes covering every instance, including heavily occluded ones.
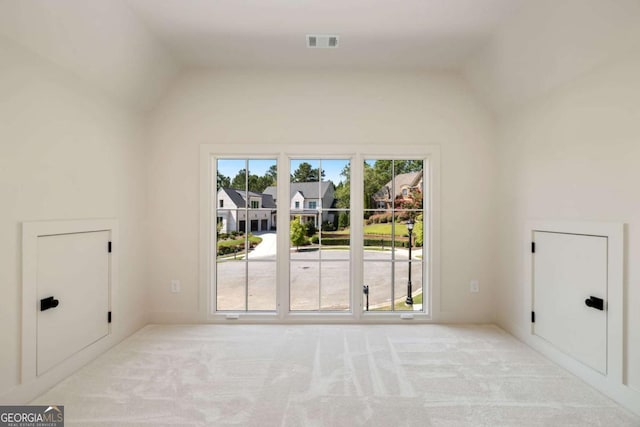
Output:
[0,36,147,402]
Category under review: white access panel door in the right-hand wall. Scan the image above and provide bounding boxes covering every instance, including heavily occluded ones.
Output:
[532,231,607,375]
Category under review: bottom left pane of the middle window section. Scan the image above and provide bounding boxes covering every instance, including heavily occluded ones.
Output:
[290,261,320,311]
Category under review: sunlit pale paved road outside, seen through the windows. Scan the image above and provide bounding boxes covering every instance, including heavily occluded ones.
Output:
[216,233,422,310]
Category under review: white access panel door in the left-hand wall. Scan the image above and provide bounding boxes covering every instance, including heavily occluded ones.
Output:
[36,231,110,375]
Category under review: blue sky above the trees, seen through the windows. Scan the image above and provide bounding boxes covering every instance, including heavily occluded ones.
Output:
[218,159,349,184]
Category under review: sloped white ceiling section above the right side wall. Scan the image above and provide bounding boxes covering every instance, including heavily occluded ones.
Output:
[465,0,640,112]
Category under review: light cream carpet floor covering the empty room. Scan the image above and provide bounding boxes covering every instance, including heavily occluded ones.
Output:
[32,325,640,427]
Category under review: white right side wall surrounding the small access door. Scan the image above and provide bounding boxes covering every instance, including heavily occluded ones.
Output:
[496,51,640,398]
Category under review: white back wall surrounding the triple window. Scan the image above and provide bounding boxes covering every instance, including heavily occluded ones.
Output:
[148,71,495,322]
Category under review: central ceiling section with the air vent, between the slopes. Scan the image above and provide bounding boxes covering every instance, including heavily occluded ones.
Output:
[127,0,523,69]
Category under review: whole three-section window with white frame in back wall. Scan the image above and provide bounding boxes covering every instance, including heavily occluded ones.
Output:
[205,146,437,321]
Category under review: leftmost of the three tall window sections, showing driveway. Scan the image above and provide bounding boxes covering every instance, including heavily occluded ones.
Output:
[214,159,277,311]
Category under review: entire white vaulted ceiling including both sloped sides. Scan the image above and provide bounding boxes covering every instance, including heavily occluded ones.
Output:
[0,0,640,111]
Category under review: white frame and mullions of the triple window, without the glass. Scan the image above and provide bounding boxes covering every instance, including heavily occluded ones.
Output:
[197,144,442,323]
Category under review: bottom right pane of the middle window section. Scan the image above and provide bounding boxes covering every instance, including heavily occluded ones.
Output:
[320,261,351,311]
